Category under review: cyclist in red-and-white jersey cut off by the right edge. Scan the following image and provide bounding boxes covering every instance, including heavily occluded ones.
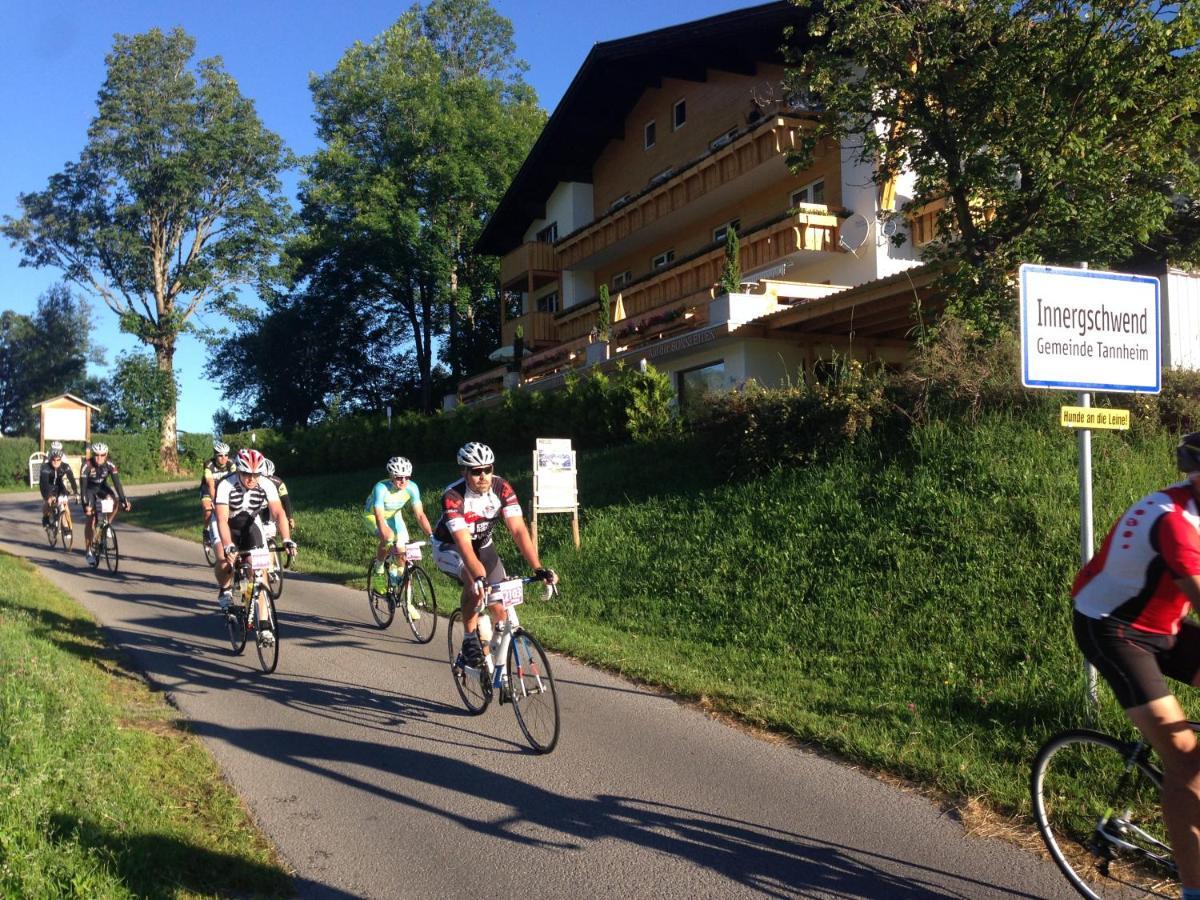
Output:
[1072,432,1200,900]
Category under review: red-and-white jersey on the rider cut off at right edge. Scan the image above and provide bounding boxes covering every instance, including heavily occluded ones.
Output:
[1070,481,1200,635]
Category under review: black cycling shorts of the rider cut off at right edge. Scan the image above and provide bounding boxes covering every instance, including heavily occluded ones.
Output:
[1074,612,1200,709]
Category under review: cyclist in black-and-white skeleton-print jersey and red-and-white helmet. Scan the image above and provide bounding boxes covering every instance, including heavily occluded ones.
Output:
[212,448,296,641]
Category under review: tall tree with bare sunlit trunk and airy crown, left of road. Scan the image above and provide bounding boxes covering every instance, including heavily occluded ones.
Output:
[2,29,288,470]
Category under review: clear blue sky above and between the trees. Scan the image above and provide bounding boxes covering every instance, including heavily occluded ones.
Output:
[0,0,755,431]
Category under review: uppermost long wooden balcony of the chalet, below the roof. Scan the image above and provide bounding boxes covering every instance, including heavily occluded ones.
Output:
[554,115,811,269]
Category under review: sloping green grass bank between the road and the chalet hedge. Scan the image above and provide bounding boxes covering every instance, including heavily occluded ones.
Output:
[131,414,1195,814]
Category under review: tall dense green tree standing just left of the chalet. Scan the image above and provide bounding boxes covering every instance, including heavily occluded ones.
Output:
[293,0,545,410]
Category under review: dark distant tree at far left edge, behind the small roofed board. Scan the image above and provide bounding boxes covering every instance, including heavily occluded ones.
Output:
[0,284,103,434]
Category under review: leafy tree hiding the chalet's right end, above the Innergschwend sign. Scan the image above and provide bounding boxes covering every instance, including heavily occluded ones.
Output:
[790,0,1200,334]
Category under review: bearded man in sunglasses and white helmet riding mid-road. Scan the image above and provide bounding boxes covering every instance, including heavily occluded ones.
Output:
[433,440,558,668]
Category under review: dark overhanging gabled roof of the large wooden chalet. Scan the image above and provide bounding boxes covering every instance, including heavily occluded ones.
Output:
[475,2,803,256]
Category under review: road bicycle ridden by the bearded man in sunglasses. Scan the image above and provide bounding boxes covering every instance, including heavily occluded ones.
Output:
[446,576,559,754]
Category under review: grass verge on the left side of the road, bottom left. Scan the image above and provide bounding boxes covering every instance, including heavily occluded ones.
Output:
[0,553,293,898]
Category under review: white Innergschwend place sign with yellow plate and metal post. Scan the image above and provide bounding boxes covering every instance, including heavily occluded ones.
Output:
[1020,263,1163,708]
